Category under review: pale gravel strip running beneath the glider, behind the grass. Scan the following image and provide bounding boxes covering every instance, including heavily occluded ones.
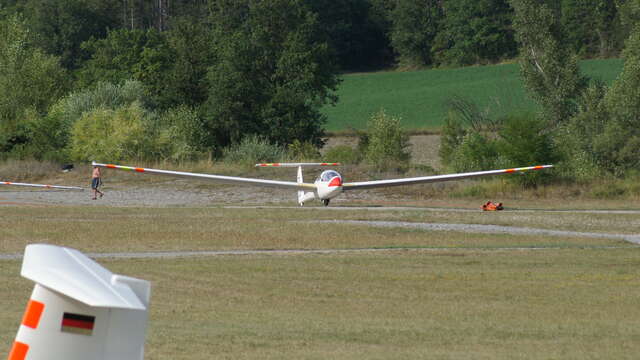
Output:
[5,187,640,215]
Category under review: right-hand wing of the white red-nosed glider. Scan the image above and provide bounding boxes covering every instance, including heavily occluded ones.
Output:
[342,165,553,191]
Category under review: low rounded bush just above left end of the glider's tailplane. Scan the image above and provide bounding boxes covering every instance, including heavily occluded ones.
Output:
[222,135,287,165]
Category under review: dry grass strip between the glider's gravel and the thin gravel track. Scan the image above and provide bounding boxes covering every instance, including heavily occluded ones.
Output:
[0,206,640,254]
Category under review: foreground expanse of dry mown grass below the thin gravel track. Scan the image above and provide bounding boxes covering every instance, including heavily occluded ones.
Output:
[0,249,640,360]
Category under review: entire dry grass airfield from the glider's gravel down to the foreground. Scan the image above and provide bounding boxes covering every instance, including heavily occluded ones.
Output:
[0,200,640,359]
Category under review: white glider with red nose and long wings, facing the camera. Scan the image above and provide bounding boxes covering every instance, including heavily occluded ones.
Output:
[93,162,553,206]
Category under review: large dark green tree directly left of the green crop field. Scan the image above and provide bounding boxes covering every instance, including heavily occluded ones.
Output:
[205,0,338,146]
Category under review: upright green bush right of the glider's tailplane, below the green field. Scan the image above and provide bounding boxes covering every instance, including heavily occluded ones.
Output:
[365,110,410,171]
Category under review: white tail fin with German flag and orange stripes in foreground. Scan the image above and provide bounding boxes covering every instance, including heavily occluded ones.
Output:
[9,244,150,360]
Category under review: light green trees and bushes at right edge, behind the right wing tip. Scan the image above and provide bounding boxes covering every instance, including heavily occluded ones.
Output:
[440,0,640,184]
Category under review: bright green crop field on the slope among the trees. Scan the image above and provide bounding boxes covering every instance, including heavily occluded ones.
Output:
[323,59,623,132]
